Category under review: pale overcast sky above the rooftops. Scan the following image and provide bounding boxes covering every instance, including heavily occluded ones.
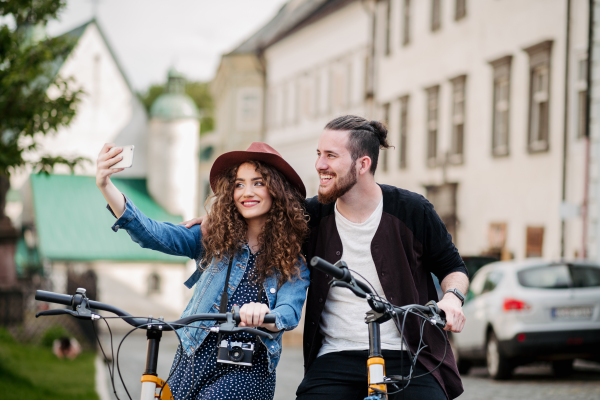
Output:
[47,0,286,91]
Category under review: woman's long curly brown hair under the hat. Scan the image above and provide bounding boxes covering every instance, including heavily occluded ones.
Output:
[202,161,308,285]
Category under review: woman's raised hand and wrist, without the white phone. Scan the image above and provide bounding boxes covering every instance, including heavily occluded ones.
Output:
[96,143,125,217]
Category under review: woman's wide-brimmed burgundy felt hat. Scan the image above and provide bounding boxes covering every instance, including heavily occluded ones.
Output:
[210,142,306,197]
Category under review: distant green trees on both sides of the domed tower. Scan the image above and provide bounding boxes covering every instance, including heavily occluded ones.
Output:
[138,82,214,134]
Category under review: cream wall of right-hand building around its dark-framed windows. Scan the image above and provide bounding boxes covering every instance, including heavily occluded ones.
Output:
[376,0,587,258]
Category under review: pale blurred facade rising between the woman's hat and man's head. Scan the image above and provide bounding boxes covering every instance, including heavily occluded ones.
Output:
[265,2,370,196]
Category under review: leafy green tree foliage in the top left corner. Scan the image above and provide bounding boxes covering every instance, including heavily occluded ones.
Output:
[0,0,83,176]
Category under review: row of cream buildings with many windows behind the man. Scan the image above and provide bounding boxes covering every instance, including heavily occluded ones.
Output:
[211,0,600,259]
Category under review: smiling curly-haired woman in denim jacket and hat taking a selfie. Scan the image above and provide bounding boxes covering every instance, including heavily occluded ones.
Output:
[96,143,309,400]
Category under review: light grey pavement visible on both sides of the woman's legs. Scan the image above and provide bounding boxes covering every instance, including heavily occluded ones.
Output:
[96,331,303,400]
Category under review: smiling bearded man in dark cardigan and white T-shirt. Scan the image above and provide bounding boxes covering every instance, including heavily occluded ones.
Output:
[187,115,469,400]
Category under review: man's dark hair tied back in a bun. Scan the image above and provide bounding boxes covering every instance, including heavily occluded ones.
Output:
[325,115,391,174]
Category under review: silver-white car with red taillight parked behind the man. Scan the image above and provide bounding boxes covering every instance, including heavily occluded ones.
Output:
[451,259,600,379]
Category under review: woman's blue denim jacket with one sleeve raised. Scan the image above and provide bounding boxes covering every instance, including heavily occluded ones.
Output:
[107,199,309,372]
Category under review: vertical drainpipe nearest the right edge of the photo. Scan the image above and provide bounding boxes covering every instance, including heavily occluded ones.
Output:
[581,0,594,259]
